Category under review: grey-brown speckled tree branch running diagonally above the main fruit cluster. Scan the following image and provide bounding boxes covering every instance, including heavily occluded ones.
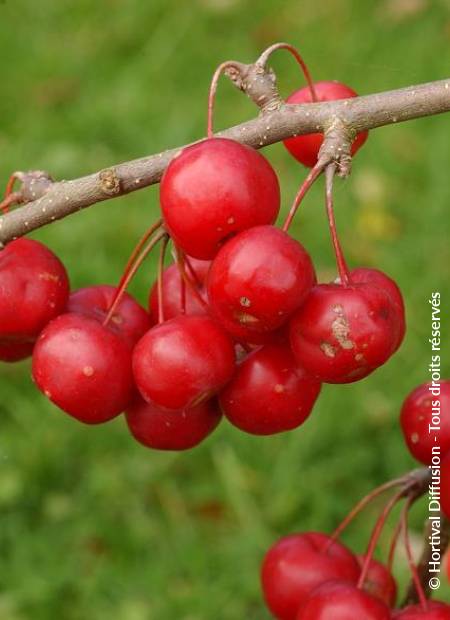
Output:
[0,71,450,248]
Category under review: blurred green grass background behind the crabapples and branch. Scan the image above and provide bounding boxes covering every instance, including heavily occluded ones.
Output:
[0,0,450,620]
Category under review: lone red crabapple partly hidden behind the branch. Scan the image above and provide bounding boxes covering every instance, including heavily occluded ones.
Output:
[284,81,369,168]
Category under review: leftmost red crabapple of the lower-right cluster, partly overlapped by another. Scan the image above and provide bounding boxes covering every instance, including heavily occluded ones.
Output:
[261,532,360,620]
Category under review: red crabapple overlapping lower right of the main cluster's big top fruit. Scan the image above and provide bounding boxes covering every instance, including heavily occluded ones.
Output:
[207,226,315,342]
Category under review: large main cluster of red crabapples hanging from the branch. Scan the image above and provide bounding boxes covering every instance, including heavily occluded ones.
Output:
[0,43,405,450]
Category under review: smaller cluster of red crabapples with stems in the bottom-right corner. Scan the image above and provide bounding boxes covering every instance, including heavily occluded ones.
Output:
[261,380,450,620]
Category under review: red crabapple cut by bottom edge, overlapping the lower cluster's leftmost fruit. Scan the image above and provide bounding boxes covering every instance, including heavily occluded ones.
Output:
[296,581,391,620]
